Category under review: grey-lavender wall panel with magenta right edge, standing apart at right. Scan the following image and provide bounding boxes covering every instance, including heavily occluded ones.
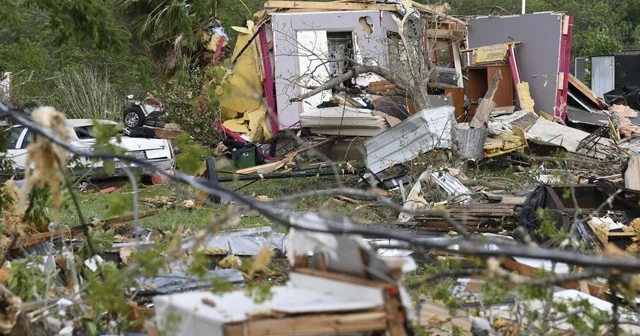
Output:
[467,12,571,117]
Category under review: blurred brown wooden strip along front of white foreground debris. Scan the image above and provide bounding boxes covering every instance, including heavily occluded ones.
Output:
[224,311,387,336]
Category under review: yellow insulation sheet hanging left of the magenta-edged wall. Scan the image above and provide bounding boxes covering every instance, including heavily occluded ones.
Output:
[216,21,272,142]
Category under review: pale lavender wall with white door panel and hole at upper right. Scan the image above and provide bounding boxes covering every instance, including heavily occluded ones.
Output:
[271,10,398,129]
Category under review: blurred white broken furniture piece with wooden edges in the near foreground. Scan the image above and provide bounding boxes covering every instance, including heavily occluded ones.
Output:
[153,213,415,336]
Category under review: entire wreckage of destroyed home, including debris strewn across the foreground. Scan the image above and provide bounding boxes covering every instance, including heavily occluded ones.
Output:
[5,1,640,335]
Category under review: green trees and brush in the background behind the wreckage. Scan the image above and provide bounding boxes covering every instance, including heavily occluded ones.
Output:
[0,0,640,122]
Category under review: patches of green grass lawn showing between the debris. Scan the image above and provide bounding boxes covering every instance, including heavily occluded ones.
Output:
[61,171,393,232]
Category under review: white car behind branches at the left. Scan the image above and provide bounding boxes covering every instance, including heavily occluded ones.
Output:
[0,119,175,179]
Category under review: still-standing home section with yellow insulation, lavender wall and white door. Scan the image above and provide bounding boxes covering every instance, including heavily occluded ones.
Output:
[216,1,466,142]
